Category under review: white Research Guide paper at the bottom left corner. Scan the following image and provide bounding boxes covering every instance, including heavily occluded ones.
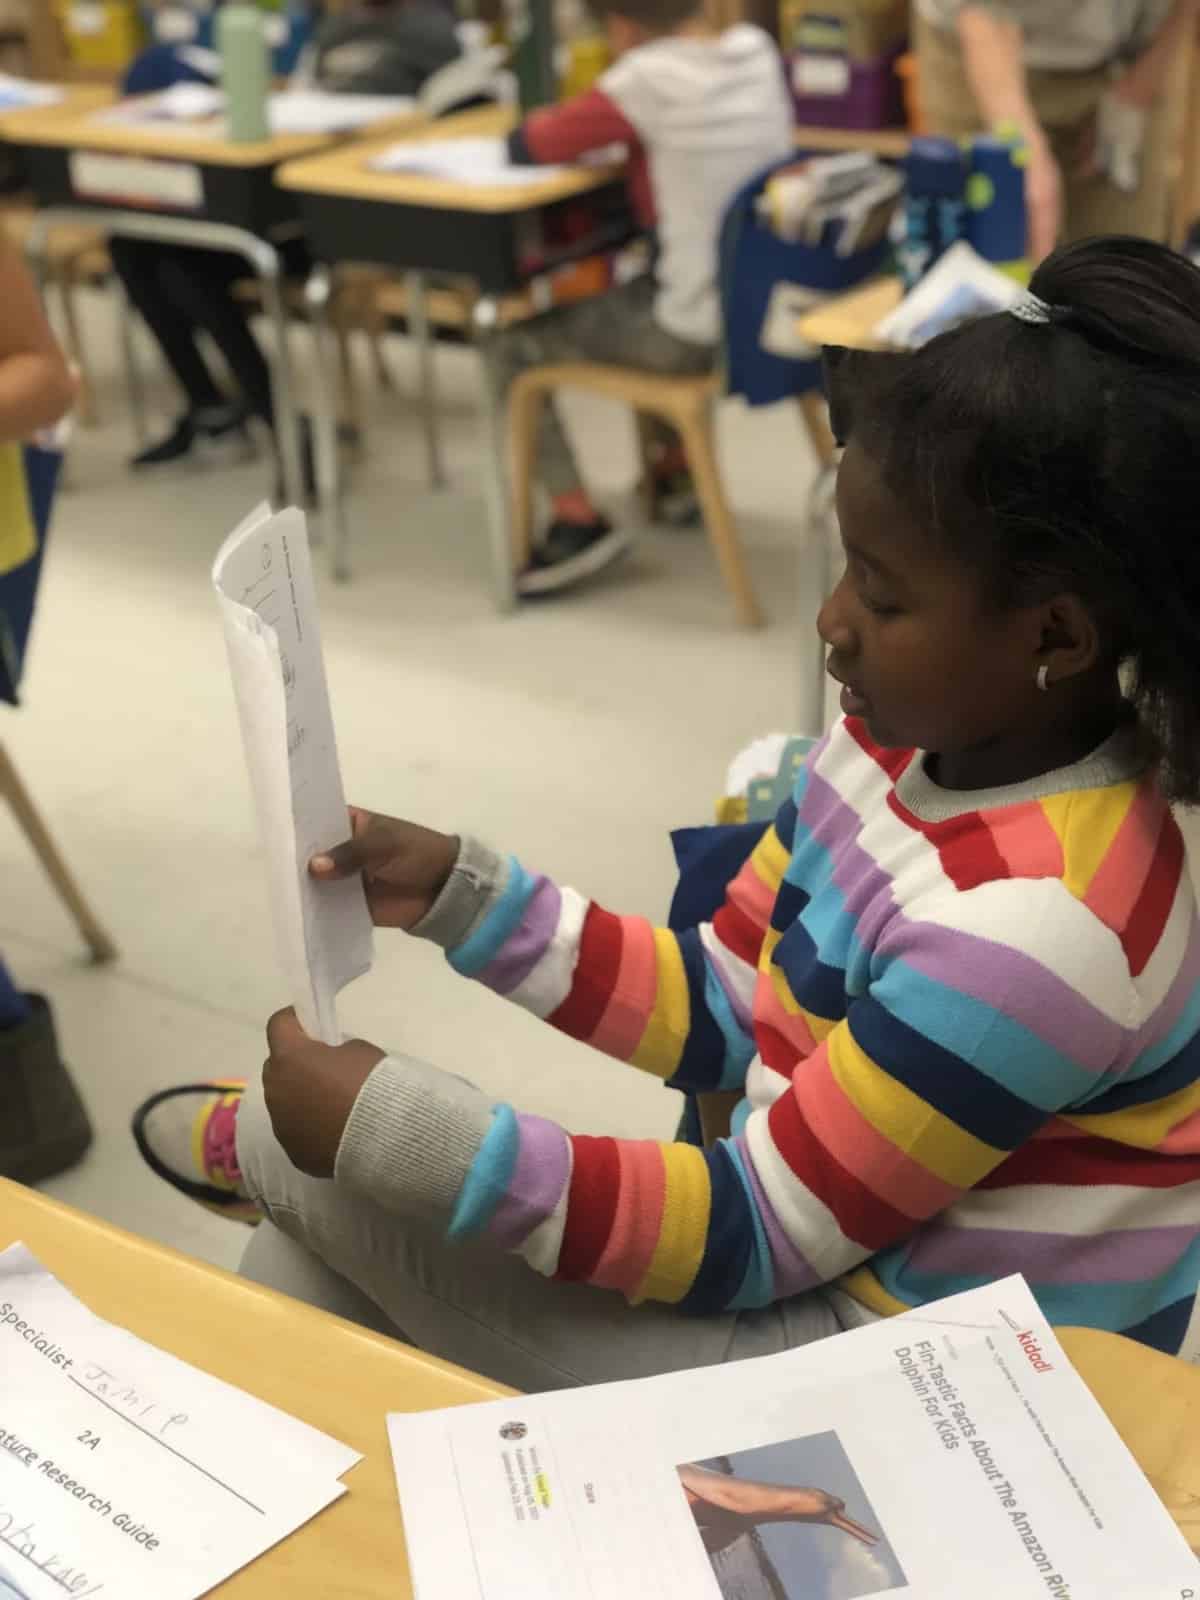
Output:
[0,1245,362,1600]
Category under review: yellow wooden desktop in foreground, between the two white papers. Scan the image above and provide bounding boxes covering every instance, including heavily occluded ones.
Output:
[0,1179,507,1600]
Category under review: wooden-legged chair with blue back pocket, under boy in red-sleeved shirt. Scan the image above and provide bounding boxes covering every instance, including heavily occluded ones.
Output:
[509,157,886,627]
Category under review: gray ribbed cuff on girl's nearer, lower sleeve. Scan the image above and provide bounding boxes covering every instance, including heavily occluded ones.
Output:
[333,1056,493,1222]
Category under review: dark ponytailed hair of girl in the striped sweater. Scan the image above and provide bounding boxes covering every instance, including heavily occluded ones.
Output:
[829,237,1200,805]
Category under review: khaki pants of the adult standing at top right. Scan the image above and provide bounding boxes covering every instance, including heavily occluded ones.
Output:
[915,18,1186,242]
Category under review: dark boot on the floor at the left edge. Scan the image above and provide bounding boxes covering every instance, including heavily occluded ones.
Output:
[0,995,91,1184]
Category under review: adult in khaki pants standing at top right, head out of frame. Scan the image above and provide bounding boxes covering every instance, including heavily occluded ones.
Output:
[915,0,1200,262]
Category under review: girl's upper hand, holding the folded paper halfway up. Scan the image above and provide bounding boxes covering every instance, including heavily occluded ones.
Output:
[309,806,459,931]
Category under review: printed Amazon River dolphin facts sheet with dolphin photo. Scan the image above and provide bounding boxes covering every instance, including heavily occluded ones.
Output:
[387,1277,1200,1600]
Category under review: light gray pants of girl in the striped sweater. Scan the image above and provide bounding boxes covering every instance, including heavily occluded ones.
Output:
[237,1082,866,1390]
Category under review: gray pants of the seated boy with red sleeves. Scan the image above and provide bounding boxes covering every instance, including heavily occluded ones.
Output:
[480,277,715,494]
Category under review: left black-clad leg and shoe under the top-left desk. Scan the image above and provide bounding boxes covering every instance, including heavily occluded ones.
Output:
[109,238,249,467]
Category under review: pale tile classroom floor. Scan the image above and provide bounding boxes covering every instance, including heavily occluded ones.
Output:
[0,288,838,1266]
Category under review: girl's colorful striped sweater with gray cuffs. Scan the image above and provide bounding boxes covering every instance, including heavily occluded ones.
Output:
[338,720,1200,1358]
